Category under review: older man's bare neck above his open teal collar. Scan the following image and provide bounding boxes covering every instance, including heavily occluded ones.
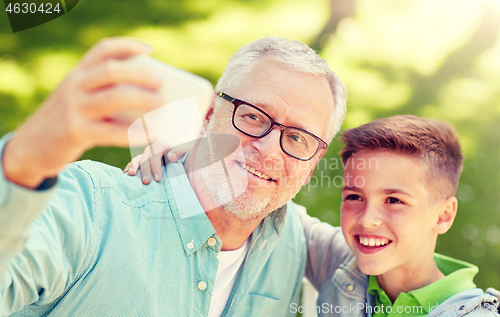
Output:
[184,151,264,251]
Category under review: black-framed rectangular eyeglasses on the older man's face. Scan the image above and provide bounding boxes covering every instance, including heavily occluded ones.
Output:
[217,92,327,161]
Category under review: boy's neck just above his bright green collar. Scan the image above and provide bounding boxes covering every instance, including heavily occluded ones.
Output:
[377,254,445,304]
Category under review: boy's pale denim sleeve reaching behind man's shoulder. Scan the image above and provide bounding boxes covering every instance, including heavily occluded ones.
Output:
[296,205,351,290]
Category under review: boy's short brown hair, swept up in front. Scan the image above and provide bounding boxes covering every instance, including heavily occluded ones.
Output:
[339,115,463,201]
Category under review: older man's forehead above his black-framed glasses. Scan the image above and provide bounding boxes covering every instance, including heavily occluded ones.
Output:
[232,58,334,138]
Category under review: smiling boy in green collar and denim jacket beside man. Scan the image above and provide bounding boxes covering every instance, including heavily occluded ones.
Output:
[302,115,499,317]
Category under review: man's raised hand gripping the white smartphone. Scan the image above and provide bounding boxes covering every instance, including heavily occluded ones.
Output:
[2,38,163,188]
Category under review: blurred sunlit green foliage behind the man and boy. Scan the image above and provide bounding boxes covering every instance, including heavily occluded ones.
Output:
[0,0,500,288]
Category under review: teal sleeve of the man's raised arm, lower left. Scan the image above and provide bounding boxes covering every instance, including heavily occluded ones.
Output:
[0,135,96,316]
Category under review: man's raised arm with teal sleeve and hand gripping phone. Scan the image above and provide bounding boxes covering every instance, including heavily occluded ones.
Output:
[0,38,162,314]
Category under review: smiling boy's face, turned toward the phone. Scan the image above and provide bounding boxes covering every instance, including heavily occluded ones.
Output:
[341,151,443,275]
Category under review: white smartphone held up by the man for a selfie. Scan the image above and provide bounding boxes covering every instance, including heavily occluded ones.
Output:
[121,55,215,157]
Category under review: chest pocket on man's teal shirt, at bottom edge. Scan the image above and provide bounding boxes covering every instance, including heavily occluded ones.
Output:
[237,294,288,316]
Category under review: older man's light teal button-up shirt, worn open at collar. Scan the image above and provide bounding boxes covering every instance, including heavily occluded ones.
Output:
[0,132,306,317]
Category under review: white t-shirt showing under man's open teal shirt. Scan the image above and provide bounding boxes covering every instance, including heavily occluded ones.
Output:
[208,240,248,317]
